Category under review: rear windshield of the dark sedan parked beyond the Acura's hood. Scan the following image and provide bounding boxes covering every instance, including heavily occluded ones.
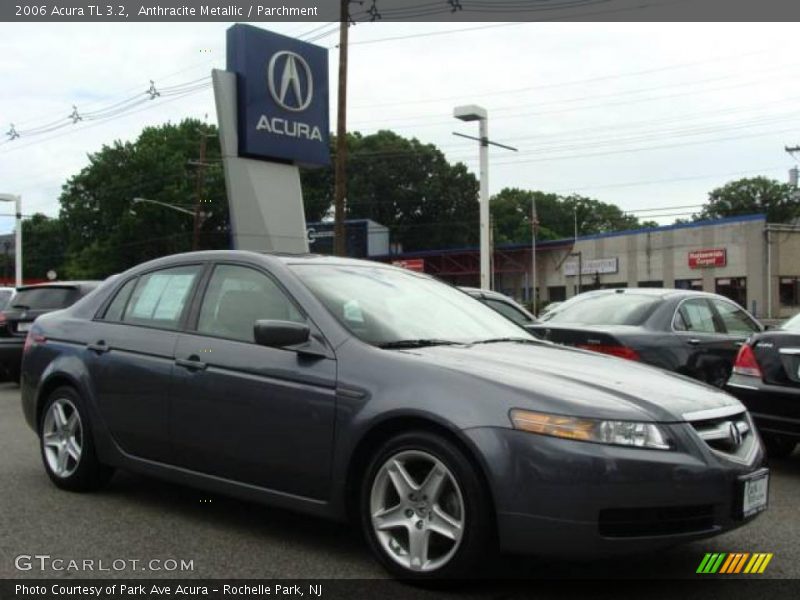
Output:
[548,293,661,325]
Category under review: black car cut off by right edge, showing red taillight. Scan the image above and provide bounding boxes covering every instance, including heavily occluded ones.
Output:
[726,315,800,456]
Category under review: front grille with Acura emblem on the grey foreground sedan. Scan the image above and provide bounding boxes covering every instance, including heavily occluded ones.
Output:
[684,407,758,464]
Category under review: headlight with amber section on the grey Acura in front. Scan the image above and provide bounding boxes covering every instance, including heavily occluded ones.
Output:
[511,408,670,450]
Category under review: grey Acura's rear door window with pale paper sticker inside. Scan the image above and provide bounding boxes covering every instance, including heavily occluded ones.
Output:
[123,265,202,329]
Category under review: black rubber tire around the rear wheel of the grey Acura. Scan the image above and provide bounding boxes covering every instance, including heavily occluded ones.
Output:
[39,387,114,492]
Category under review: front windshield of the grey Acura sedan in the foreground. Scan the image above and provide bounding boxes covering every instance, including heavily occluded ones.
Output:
[292,265,534,346]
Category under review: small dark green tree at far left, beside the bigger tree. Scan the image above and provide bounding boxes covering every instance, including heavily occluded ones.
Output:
[22,213,67,279]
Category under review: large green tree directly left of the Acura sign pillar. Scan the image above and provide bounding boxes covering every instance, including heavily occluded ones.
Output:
[60,119,228,278]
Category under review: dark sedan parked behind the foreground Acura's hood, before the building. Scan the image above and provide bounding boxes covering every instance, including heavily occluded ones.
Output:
[531,288,762,387]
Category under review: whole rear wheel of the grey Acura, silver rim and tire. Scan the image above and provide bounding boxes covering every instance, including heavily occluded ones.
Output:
[39,387,114,491]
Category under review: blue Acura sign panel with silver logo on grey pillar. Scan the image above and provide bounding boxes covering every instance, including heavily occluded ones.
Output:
[227,25,330,165]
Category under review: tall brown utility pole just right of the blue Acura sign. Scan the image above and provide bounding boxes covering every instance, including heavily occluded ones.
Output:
[333,0,350,256]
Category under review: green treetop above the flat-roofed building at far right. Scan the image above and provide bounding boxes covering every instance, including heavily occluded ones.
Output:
[693,177,800,223]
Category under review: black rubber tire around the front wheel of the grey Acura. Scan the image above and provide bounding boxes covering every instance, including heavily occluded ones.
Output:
[358,431,496,582]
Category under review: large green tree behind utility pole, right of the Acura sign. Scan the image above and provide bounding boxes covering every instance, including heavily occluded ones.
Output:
[302,131,478,250]
